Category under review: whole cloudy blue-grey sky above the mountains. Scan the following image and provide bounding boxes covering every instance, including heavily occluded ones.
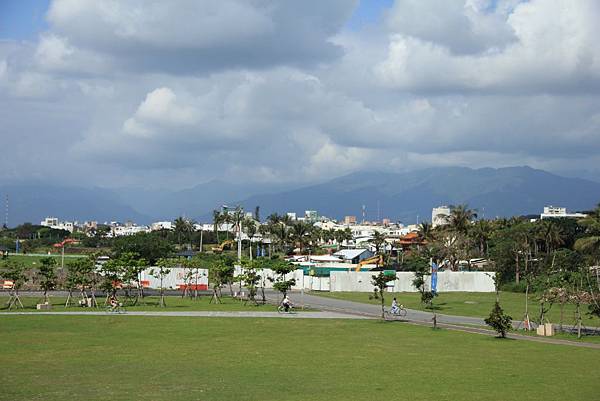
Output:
[0,0,600,189]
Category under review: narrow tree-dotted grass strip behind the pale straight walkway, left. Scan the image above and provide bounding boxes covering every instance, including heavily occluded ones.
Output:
[0,295,277,313]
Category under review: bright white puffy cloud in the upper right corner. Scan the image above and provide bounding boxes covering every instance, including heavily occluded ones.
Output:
[376,0,600,93]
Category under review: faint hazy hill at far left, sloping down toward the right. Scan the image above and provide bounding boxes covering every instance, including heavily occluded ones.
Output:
[0,183,151,227]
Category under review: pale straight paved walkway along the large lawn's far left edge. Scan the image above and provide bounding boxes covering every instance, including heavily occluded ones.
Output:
[0,311,371,319]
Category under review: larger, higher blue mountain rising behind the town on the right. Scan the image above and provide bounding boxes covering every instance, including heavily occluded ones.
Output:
[233,167,600,223]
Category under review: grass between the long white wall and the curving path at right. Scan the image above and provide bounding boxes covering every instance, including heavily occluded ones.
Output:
[311,291,600,326]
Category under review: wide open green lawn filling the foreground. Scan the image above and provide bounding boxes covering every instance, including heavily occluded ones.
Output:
[0,315,600,401]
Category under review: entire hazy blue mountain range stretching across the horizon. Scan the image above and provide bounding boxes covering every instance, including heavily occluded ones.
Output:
[0,167,600,226]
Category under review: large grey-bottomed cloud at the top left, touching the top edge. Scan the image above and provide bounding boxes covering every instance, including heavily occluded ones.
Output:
[48,0,357,73]
